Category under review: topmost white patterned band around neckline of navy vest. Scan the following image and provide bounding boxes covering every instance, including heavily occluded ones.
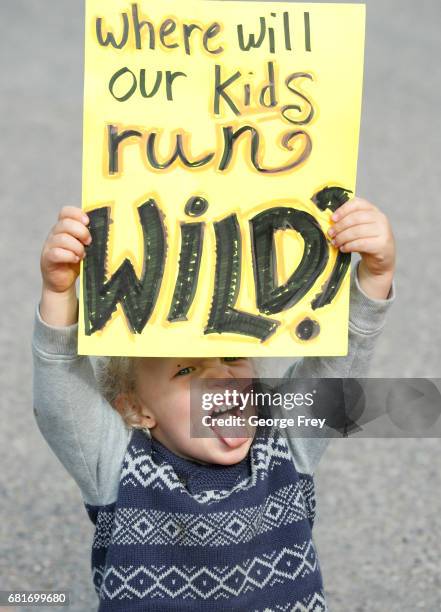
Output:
[120,431,292,504]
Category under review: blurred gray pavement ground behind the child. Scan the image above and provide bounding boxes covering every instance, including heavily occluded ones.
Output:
[0,0,441,612]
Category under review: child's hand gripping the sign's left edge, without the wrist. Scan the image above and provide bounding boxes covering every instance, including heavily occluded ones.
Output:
[40,206,92,293]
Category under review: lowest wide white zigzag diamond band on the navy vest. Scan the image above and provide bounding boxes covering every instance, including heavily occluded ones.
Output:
[96,540,320,600]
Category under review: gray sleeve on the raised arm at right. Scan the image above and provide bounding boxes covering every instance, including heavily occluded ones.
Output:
[284,262,395,474]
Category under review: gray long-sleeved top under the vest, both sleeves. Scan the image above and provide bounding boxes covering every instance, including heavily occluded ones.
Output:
[32,265,395,506]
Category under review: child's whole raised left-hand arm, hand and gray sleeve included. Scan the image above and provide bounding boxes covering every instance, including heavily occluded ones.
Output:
[32,207,129,505]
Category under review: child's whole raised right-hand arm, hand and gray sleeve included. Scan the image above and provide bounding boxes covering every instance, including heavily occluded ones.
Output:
[285,198,395,474]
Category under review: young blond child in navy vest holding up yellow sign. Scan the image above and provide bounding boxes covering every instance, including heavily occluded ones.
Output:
[33,198,395,612]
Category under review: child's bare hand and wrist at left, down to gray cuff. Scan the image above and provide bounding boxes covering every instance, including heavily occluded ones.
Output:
[40,206,92,326]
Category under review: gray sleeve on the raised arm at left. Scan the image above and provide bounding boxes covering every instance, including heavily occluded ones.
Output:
[32,305,130,505]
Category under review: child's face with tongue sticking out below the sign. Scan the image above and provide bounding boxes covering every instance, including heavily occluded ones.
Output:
[129,357,256,465]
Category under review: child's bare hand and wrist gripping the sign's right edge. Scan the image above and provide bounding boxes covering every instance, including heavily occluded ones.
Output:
[328,198,395,299]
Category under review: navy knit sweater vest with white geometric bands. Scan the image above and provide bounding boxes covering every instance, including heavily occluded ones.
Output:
[85,429,327,612]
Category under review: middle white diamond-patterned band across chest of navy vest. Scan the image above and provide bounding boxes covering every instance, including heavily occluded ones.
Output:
[93,479,314,548]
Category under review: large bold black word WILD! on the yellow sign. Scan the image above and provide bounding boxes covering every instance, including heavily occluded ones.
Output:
[83,187,350,342]
